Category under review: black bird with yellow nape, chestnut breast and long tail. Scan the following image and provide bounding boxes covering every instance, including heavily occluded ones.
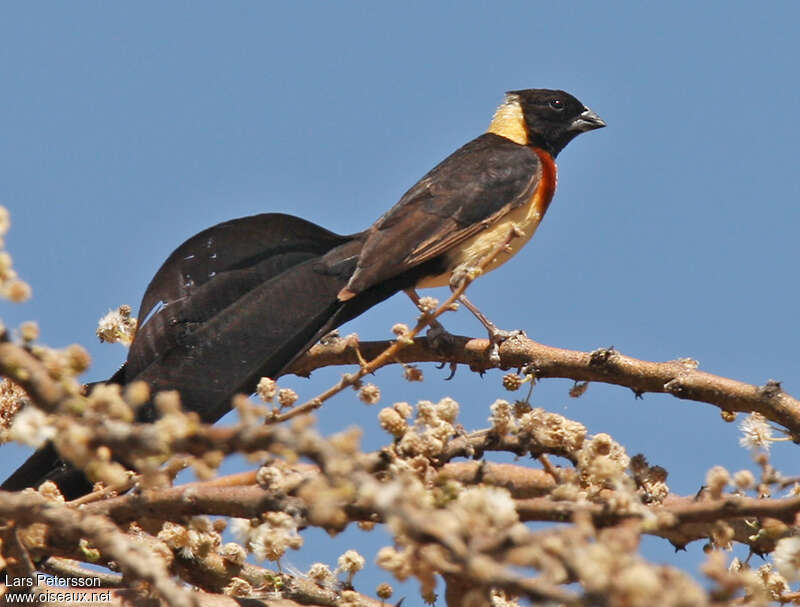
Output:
[2,89,606,499]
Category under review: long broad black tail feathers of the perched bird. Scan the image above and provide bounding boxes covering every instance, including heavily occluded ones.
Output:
[2,214,438,499]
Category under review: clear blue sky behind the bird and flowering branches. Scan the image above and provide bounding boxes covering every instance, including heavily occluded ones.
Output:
[0,2,800,600]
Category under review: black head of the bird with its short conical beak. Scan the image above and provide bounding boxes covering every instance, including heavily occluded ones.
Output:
[498,89,606,156]
